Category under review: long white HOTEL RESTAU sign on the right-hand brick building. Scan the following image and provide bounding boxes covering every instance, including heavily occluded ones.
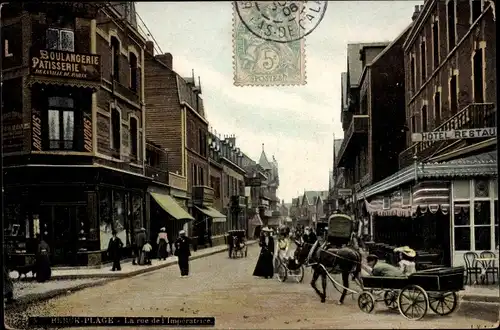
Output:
[411,127,497,142]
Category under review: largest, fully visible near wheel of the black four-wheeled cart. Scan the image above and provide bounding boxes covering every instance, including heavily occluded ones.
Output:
[398,285,429,321]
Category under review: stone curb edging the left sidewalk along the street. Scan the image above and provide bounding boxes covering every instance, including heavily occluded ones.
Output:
[5,241,257,311]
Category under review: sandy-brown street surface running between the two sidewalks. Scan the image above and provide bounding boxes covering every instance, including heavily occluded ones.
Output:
[6,245,499,329]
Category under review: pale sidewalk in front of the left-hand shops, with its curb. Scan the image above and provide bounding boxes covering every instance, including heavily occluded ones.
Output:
[6,241,257,309]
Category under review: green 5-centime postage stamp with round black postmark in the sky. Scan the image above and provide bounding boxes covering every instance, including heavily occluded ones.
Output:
[233,1,306,86]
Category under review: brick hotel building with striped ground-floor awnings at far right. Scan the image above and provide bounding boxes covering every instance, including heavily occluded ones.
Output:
[358,0,498,265]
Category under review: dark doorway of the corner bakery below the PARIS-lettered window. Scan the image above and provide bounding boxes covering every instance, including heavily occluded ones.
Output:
[49,205,81,266]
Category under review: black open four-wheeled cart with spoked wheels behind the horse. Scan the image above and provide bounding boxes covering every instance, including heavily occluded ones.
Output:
[358,267,464,320]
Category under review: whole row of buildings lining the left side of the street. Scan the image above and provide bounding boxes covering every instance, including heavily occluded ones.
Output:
[2,2,281,266]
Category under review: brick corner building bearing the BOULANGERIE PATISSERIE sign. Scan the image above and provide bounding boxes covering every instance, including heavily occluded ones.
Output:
[2,2,168,265]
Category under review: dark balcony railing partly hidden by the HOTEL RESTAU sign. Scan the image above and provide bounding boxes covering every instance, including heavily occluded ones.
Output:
[399,103,496,168]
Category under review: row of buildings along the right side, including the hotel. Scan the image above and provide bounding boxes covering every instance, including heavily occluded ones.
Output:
[310,0,499,266]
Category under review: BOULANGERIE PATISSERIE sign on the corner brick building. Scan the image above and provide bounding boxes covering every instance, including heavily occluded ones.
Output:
[30,50,101,81]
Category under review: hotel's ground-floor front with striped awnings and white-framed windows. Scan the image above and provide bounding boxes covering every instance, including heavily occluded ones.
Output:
[357,152,498,265]
